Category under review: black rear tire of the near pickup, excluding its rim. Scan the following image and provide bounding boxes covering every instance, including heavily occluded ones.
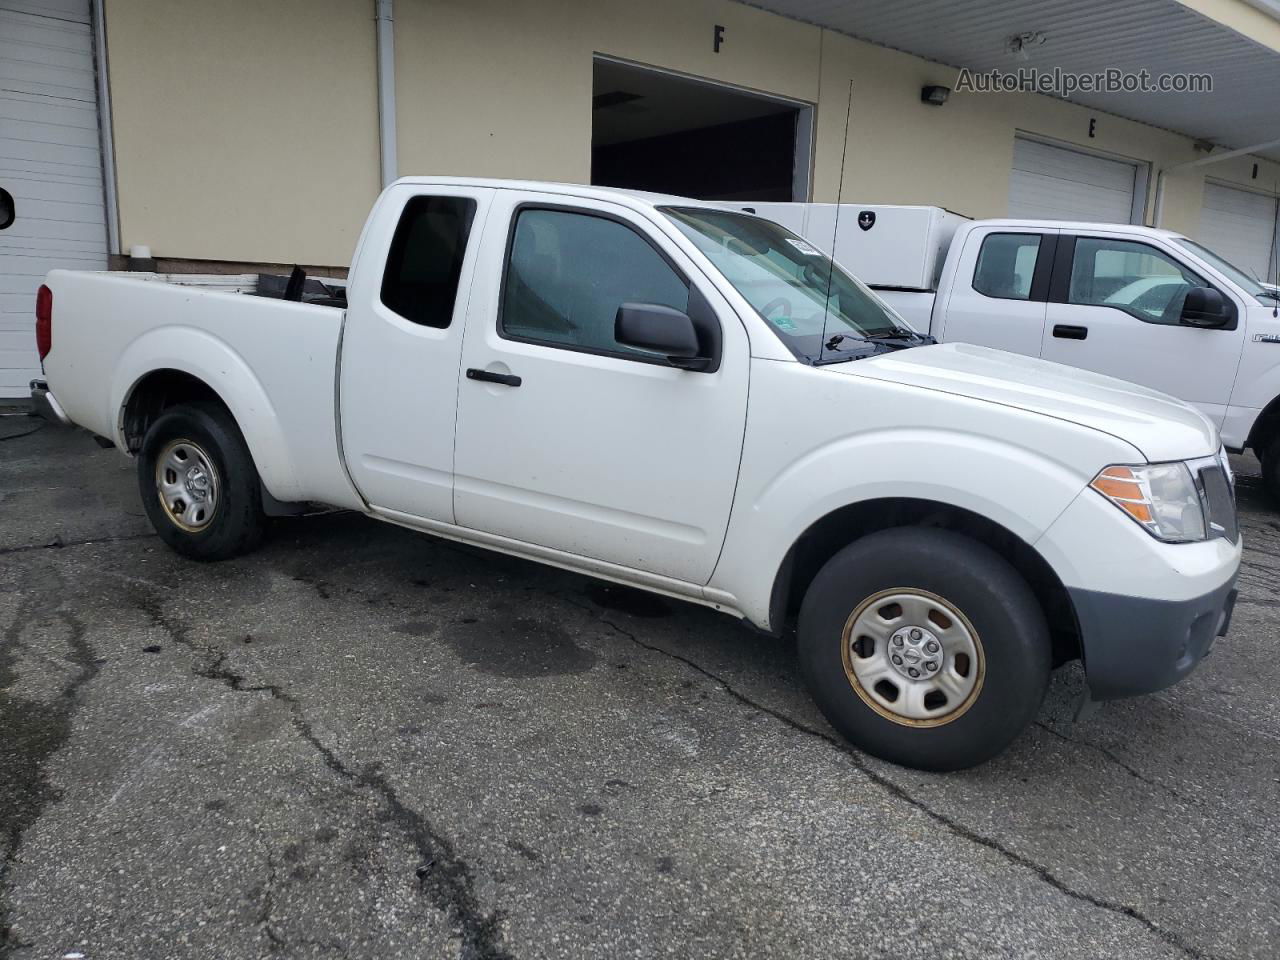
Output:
[137,403,265,561]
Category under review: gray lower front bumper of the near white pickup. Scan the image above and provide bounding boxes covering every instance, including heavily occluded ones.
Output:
[1068,576,1235,700]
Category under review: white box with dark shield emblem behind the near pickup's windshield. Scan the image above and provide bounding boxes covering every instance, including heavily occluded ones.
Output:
[726,202,968,291]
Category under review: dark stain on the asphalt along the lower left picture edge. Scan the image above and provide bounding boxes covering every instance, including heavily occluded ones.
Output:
[0,591,102,960]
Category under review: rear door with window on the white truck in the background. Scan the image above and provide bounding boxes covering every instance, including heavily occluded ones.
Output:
[938,228,1056,357]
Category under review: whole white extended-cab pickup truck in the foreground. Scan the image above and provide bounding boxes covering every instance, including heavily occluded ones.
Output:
[20,178,1240,769]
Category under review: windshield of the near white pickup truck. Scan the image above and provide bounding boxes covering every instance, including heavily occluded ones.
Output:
[663,207,931,364]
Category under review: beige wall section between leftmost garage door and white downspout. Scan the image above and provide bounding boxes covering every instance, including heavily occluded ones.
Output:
[105,0,379,265]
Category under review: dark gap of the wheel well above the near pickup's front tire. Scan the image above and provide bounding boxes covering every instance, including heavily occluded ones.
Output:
[769,498,1080,664]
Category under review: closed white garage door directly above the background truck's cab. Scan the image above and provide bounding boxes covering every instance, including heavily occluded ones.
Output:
[1009,137,1138,223]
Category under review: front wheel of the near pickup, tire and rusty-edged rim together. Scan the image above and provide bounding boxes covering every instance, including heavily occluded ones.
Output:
[799,527,1051,771]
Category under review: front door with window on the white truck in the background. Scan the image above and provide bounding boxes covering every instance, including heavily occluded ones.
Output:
[1041,237,1244,426]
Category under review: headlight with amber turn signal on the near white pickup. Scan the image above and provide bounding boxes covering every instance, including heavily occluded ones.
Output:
[1089,463,1206,543]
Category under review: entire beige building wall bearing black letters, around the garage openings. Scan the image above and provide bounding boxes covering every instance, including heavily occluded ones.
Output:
[108,0,1280,265]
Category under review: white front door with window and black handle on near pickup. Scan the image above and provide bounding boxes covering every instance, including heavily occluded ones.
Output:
[454,191,749,584]
